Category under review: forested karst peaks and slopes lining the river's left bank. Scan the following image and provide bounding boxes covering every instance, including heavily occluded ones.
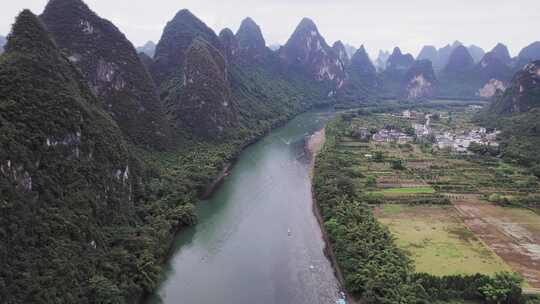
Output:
[0,0,372,303]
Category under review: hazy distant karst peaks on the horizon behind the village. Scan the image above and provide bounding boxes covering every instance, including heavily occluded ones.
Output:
[375,41,540,98]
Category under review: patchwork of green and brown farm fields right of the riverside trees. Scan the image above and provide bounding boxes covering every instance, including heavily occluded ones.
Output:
[338,108,540,288]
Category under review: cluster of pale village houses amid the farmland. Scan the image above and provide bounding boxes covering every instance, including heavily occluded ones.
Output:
[357,110,500,153]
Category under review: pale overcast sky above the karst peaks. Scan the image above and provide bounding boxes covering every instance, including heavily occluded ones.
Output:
[0,0,540,56]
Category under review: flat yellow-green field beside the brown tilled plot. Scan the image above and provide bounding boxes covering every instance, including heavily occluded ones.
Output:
[376,204,511,275]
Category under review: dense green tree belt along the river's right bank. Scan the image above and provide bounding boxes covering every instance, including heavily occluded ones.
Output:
[313,117,526,303]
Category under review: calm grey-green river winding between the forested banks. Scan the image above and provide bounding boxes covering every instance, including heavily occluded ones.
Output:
[150,110,339,304]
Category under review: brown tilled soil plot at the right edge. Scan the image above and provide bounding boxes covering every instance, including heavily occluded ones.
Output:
[454,199,540,288]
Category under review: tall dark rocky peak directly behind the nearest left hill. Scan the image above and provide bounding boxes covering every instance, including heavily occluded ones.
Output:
[40,0,170,150]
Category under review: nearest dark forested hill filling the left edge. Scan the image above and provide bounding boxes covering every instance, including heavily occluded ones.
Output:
[0,10,144,303]
